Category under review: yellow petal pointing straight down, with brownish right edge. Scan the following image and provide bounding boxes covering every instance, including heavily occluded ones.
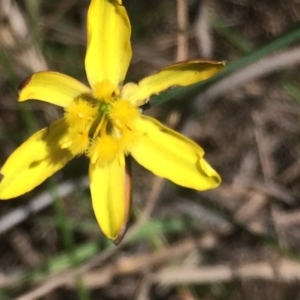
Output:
[89,158,131,243]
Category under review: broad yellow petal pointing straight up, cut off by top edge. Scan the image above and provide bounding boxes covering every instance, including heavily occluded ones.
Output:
[85,0,132,88]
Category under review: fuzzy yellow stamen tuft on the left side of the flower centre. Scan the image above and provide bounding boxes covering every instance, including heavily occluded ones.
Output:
[65,99,97,132]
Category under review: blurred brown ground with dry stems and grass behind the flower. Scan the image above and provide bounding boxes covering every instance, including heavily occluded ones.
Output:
[0,0,300,300]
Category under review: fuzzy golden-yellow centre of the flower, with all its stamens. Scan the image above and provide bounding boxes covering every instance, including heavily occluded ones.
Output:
[60,84,140,164]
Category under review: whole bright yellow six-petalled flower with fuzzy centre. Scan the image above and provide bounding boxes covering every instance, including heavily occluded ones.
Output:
[0,0,224,242]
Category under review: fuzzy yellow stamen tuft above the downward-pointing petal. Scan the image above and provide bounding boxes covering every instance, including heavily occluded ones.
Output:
[88,135,121,164]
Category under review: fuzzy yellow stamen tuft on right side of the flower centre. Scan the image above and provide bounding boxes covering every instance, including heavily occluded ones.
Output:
[109,100,140,130]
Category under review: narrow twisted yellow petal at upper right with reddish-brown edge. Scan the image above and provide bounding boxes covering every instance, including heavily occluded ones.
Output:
[121,60,224,106]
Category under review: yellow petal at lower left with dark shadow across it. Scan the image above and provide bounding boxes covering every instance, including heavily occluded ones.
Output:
[0,119,72,200]
